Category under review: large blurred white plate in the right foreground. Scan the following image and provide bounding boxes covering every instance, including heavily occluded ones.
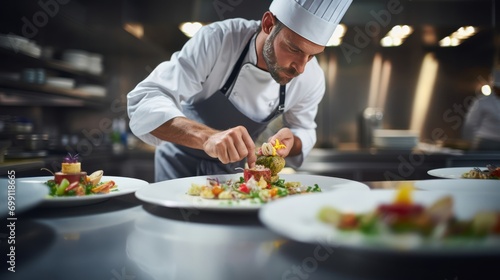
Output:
[259,190,500,255]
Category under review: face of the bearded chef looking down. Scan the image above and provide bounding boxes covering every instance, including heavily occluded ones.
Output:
[263,23,324,85]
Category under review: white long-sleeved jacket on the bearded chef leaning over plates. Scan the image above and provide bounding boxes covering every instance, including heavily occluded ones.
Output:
[127,19,325,167]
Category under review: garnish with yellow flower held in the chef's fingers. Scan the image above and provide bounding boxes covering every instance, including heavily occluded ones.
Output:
[255,139,286,182]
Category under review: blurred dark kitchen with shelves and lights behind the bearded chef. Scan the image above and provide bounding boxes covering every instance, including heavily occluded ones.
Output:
[0,0,500,182]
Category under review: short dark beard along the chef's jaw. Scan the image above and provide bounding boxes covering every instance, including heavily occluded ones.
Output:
[263,33,298,85]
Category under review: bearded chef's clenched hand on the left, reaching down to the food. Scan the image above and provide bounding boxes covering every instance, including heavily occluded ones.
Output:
[203,126,257,168]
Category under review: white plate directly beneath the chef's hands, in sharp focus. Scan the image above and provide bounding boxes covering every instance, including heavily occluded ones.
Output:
[135,173,370,211]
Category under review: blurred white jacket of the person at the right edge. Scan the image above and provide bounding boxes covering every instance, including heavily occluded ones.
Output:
[463,93,500,141]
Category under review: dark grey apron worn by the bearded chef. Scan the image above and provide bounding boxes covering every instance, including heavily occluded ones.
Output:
[155,40,285,182]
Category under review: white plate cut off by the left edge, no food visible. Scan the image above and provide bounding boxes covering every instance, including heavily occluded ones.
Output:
[0,178,49,218]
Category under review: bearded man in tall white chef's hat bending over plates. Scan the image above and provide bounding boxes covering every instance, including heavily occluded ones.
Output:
[127,0,352,181]
